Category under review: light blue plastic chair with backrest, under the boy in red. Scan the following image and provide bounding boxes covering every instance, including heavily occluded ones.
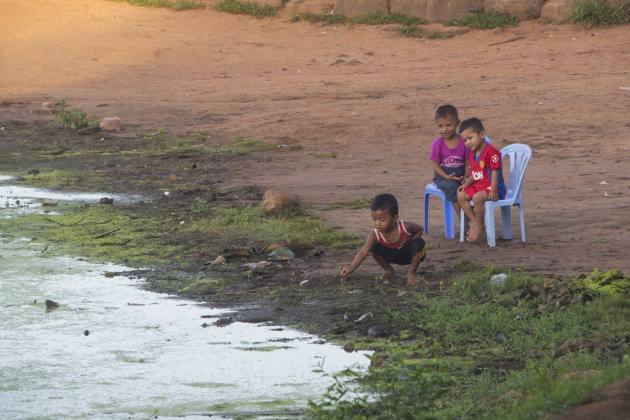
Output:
[459,143,532,246]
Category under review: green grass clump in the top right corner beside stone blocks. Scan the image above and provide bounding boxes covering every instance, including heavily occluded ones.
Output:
[569,0,630,28]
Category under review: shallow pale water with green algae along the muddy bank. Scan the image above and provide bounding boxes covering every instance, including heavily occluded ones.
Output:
[0,184,369,419]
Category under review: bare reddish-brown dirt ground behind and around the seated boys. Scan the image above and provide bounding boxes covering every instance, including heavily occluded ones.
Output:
[0,0,630,274]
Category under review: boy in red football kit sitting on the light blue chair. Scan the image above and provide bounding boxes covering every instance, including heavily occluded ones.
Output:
[457,118,505,242]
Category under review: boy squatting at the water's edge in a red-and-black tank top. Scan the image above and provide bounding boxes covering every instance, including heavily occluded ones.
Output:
[341,194,427,285]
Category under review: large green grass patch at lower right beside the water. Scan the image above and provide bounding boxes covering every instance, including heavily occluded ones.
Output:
[310,268,630,419]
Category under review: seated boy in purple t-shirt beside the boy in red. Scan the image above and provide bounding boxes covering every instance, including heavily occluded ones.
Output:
[429,105,468,215]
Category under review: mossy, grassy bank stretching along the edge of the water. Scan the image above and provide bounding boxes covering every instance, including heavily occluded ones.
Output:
[0,121,630,418]
